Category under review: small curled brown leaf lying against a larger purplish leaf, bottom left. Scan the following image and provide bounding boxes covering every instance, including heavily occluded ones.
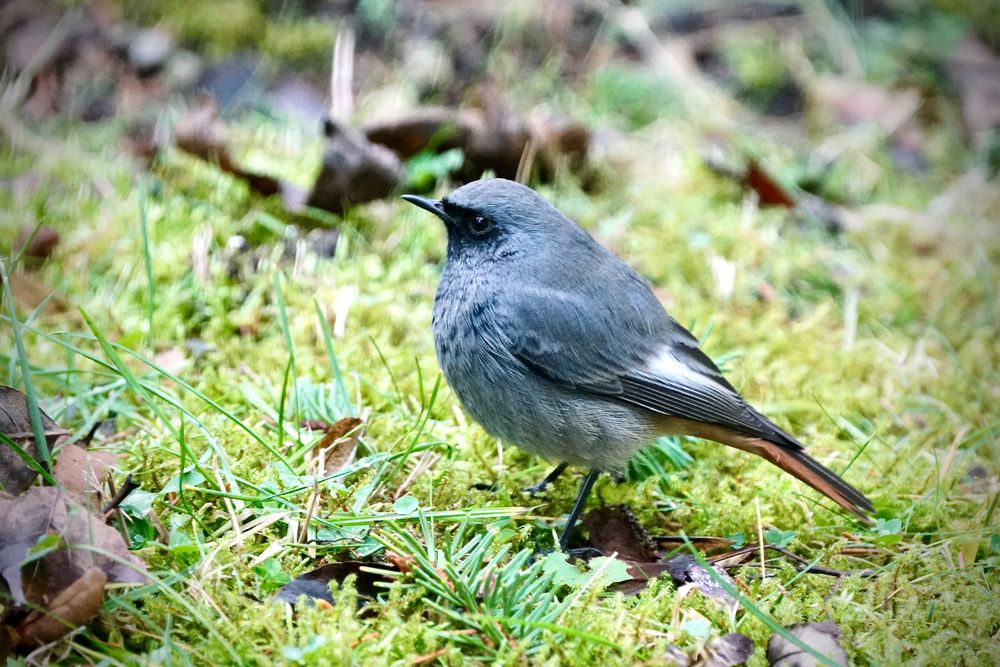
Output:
[17,567,108,648]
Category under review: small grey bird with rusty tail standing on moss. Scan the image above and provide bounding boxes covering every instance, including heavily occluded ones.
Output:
[403,178,874,549]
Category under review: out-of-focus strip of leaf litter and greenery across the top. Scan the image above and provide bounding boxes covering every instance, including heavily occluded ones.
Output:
[0,0,1000,217]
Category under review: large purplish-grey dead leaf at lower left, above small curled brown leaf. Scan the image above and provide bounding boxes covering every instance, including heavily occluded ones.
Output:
[0,487,147,605]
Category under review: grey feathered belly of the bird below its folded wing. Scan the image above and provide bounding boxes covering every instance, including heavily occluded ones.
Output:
[439,336,654,470]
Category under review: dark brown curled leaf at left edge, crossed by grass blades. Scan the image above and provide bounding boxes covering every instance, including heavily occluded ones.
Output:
[0,385,69,495]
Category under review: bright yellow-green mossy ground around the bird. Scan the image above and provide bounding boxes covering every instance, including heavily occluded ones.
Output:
[0,3,1000,665]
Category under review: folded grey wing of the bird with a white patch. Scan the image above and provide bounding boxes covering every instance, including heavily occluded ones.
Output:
[499,282,801,448]
